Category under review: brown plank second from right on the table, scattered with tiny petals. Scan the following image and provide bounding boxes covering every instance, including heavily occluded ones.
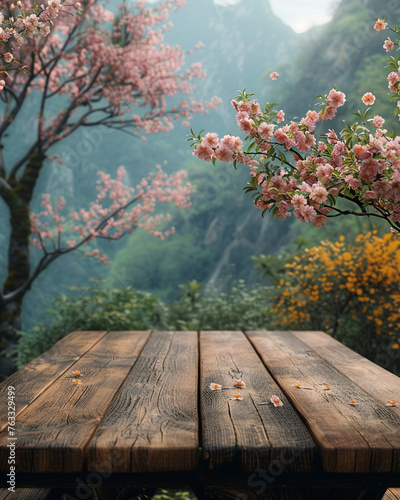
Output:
[247,332,400,472]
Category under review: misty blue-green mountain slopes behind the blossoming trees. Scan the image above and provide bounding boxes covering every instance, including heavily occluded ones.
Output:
[18,0,399,326]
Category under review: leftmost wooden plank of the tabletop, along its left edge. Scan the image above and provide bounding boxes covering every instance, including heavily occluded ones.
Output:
[0,331,106,431]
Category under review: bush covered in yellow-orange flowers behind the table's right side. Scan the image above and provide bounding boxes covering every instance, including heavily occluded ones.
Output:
[272,231,400,370]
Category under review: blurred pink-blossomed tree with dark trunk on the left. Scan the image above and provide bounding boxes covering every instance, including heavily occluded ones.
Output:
[0,0,217,374]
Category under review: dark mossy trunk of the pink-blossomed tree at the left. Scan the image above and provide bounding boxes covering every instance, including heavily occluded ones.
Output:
[0,153,44,377]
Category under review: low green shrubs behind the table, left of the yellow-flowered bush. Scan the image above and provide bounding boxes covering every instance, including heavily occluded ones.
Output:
[16,281,271,368]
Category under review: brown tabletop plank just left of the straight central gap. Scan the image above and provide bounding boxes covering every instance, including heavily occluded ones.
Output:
[88,332,199,473]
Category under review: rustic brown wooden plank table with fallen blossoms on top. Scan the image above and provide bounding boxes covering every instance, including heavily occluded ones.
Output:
[0,331,400,500]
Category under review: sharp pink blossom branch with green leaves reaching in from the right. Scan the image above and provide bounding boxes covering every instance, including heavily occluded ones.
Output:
[188,19,400,233]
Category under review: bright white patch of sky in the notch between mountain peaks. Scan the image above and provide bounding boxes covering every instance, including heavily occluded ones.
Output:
[214,0,338,33]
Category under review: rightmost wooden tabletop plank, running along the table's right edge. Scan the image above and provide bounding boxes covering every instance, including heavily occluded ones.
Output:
[292,331,400,406]
